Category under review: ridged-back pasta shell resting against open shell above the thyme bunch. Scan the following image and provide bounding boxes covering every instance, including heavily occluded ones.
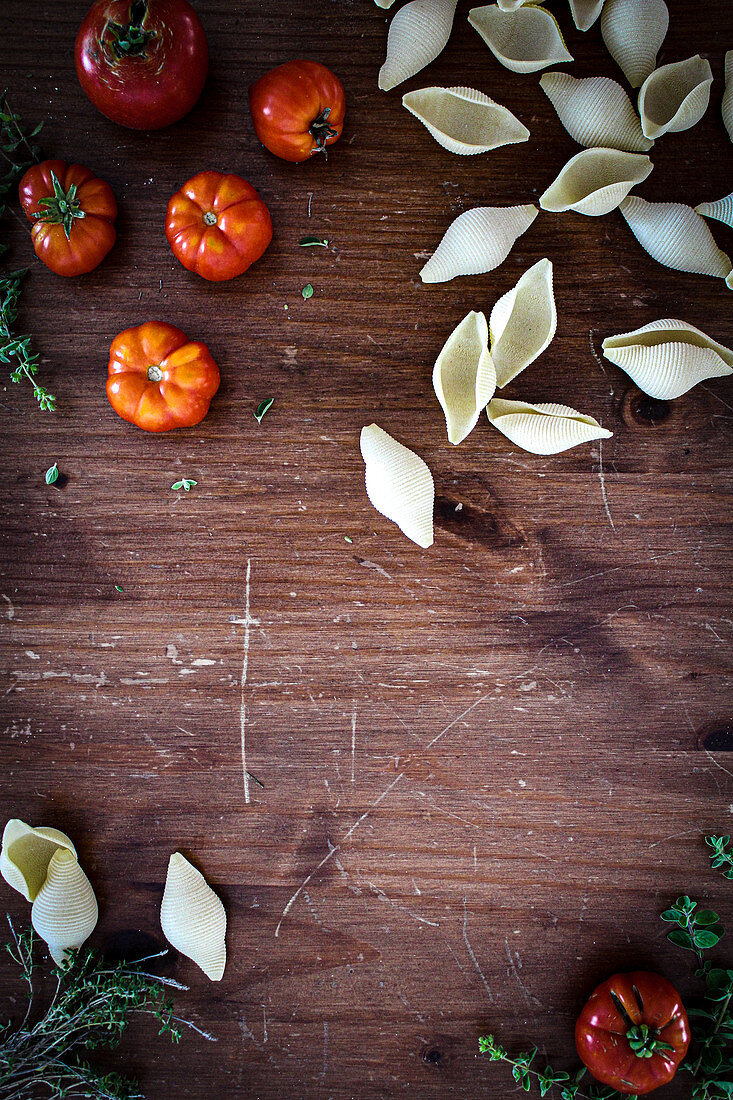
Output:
[31,848,99,966]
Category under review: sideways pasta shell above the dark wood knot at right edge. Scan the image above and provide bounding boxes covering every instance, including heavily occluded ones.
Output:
[603,317,733,402]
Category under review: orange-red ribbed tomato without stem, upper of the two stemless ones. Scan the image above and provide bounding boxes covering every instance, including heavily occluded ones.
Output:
[165,172,272,283]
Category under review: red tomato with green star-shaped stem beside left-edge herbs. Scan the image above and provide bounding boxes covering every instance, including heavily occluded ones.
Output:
[18,161,117,275]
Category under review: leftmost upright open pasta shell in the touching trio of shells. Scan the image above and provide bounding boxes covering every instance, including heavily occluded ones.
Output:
[433,311,496,443]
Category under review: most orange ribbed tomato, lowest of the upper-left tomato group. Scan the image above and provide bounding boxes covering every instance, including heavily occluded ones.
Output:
[107,321,219,431]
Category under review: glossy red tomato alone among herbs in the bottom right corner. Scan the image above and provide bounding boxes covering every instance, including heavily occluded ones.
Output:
[576,970,690,1096]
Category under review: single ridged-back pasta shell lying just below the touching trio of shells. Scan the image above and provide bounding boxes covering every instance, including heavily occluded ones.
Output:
[360,424,435,548]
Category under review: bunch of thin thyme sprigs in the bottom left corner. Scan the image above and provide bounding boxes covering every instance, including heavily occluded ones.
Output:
[0,924,212,1100]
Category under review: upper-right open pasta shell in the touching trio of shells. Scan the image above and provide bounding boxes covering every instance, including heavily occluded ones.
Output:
[489,260,557,387]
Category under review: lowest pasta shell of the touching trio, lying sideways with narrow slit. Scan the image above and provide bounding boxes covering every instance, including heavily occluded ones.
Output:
[486,397,613,454]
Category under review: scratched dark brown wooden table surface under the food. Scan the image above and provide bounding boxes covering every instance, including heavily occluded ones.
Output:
[0,0,733,1100]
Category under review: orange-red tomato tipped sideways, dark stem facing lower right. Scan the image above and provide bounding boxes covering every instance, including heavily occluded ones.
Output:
[250,61,346,163]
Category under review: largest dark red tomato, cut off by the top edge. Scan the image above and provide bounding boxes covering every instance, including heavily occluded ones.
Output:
[75,0,209,130]
